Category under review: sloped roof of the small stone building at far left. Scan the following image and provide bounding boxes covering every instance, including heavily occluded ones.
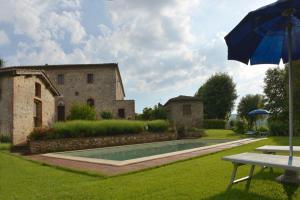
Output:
[0,67,60,96]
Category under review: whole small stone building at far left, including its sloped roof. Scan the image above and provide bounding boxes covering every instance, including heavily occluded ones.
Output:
[0,68,59,146]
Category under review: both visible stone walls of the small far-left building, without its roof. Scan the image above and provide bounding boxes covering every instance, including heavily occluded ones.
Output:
[0,74,55,146]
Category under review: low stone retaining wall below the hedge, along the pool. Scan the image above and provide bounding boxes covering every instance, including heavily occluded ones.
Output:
[29,133,177,154]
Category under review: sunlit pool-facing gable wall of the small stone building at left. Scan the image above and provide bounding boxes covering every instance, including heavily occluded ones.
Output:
[12,76,55,145]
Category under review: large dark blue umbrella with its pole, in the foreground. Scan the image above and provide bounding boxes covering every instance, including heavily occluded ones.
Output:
[225,0,300,160]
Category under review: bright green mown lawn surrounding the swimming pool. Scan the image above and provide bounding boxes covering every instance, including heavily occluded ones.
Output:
[0,130,300,200]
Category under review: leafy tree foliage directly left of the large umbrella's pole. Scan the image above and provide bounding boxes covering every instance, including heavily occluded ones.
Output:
[264,68,289,121]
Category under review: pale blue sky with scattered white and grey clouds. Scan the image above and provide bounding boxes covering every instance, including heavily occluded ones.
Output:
[0,0,282,112]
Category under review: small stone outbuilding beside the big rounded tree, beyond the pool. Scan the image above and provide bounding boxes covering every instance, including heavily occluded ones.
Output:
[164,96,203,128]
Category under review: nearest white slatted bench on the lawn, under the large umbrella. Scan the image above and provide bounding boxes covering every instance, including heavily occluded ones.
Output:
[222,153,300,190]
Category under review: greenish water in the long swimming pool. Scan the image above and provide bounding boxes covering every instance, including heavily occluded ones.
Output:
[58,139,230,161]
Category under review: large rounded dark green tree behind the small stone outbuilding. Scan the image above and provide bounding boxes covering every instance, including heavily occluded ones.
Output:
[196,73,237,119]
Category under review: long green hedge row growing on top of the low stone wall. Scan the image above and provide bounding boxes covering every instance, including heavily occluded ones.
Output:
[29,120,169,140]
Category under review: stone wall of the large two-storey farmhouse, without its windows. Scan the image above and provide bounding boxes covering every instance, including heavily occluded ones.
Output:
[42,65,135,119]
